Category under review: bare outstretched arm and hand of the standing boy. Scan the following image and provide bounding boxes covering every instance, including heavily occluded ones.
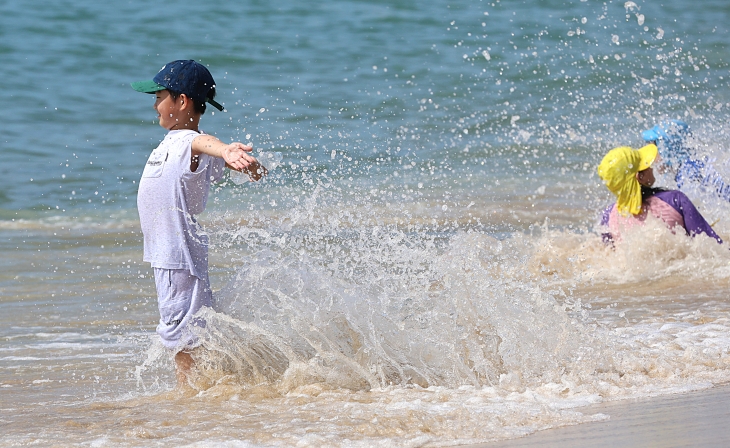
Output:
[190,134,266,181]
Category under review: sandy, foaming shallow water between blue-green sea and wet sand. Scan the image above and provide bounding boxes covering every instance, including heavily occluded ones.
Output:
[0,212,730,446]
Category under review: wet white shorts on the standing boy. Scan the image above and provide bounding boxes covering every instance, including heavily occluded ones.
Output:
[153,268,213,350]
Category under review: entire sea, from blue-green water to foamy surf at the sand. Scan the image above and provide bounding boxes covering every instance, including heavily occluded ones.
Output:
[0,0,730,447]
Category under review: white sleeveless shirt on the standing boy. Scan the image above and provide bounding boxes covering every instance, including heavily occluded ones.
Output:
[137,130,225,279]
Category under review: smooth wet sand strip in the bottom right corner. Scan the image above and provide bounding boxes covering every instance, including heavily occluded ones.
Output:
[470,385,730,448]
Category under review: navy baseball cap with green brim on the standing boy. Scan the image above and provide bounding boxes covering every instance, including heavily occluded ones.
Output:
[132,60,223,111]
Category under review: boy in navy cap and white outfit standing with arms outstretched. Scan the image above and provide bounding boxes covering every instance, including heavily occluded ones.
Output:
[132,60,266,387]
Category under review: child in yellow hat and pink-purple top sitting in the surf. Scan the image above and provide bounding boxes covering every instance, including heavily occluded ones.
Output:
[598,144,722,243]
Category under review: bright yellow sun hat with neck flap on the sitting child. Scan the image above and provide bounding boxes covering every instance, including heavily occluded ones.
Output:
[598,144,657,215]
